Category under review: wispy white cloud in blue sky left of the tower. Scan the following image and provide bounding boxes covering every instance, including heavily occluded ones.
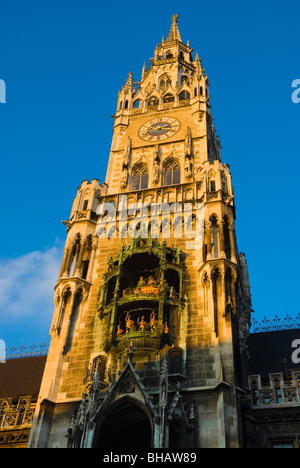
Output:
[0,247,62,326]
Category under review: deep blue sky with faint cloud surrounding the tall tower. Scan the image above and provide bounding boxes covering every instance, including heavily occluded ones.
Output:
[0,0,300,347]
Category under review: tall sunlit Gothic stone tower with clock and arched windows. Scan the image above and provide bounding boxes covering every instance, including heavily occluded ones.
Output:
[29,15,251,448]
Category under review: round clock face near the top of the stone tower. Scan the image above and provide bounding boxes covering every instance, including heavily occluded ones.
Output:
[139,117,180,141]
